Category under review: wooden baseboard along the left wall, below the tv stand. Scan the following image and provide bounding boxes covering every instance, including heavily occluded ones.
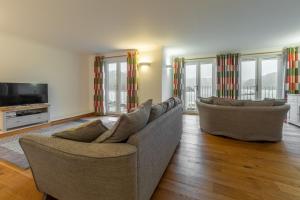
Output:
[0,112,95,138]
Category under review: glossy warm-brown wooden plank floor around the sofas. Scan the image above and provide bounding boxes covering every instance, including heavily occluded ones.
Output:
[0,115,300,200]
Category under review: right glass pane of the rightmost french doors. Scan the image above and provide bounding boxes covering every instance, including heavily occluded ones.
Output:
[261,58,278,99]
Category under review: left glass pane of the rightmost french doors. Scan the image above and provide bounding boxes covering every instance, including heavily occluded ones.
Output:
[241,60,256,99]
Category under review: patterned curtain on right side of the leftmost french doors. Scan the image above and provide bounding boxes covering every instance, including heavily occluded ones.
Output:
[127,51,138,112]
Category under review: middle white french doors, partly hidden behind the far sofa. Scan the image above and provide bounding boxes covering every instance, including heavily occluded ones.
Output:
[184,60,216,112]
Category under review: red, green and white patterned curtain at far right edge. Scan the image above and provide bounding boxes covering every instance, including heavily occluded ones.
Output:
[284,47,300,94]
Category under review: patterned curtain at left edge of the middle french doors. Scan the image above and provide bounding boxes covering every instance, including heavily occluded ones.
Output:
[173,58,184,99]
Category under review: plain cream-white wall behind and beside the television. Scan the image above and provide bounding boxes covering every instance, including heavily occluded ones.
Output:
[0,33,90,120]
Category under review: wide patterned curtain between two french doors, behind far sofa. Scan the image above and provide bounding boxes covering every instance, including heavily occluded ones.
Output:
[217,54,239,99]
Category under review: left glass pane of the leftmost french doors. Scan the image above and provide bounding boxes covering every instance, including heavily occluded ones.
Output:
[107,63,117,112]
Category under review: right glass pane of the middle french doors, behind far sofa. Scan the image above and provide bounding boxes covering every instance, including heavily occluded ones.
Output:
[200,64,213,97]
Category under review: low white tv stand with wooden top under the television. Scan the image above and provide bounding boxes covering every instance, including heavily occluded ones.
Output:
[0,104,49,131]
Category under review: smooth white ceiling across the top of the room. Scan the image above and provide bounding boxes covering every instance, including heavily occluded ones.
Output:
[0,0,300,55]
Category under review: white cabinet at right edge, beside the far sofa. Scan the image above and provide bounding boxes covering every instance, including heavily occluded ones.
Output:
[287,94,300,126]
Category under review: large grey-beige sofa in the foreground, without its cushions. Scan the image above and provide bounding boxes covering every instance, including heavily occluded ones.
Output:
[20,105,182,200]
